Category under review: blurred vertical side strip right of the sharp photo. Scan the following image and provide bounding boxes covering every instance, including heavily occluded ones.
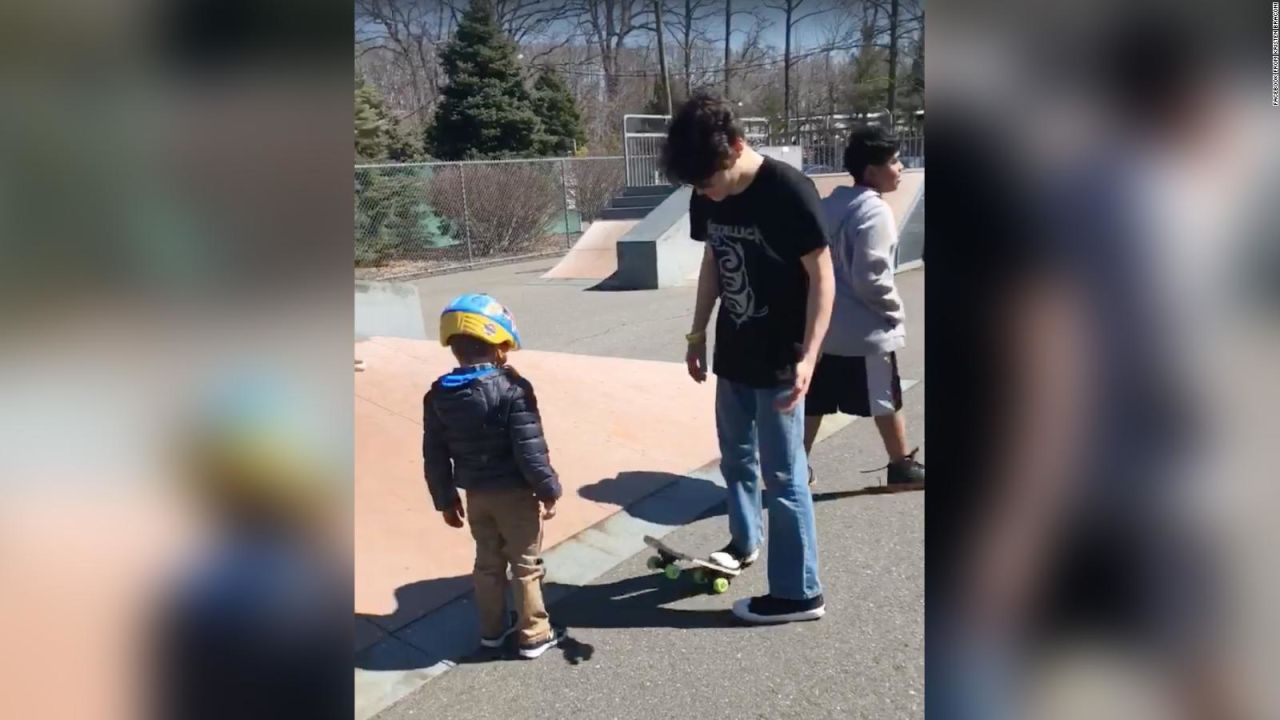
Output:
[925,1,1280,719]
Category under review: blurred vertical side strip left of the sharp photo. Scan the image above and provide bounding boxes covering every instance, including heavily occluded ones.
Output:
[0,0,352,719]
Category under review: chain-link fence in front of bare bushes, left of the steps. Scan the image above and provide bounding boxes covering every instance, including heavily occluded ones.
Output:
[356,158,626,279]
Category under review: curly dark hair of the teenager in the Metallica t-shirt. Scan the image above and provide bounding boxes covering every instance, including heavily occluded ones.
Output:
[660,91,744,186]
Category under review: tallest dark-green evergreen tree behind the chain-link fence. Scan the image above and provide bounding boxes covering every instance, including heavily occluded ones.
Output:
[426,0,540,160]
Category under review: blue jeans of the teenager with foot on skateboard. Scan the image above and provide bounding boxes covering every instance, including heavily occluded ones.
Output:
[716,378,822,600]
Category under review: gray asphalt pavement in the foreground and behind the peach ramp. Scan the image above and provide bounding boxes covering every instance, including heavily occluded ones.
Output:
[378,261,927,720]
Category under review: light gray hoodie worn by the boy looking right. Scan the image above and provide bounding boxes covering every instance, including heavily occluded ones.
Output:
[822,186,906,355]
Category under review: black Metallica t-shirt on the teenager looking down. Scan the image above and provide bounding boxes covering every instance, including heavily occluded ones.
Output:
[689,158,827,388]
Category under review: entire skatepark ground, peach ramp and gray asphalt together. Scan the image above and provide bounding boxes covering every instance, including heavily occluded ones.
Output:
[356,260,924,719]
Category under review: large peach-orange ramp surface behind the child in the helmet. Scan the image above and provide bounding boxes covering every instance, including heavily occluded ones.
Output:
[355,338,719,630]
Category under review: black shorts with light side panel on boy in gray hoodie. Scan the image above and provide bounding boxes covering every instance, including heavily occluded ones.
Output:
[804,352,902,418]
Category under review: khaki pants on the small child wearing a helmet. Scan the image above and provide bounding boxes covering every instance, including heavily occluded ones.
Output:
[467,489,552,644]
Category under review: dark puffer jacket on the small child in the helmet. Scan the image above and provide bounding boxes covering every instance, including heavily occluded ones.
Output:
[422,368,561,511]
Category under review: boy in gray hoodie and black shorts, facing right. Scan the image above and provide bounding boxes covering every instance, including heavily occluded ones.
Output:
[805,127,924,486]
